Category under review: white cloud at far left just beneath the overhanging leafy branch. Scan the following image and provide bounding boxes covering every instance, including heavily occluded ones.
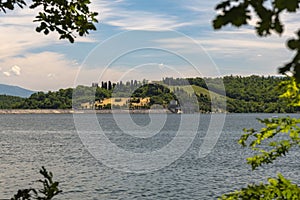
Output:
[0,8,94,60]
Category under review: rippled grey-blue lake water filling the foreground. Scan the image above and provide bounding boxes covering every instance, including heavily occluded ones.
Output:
[0,114,300,200]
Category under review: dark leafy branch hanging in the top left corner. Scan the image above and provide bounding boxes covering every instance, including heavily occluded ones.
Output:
[0,0,98,43]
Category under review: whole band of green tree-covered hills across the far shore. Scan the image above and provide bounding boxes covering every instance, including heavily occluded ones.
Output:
[0,76,299,113]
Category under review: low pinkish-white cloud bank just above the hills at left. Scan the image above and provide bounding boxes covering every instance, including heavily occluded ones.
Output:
[0,52,130,91]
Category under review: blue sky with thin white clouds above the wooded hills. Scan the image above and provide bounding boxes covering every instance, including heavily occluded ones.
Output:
[0,0,299,91]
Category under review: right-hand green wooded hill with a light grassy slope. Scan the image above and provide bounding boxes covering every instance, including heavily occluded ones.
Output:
[162,75,299,113]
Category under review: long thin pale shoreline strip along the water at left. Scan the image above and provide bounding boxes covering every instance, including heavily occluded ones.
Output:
[0,109,171,114]
